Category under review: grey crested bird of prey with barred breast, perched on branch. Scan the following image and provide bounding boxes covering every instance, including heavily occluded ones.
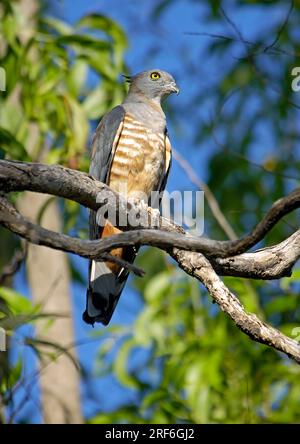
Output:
[83,69,179,325]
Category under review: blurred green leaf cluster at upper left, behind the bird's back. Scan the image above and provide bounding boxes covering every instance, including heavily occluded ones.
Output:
[0,3,126,169]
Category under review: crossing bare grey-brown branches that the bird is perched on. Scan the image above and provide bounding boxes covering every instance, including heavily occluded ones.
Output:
[0,160,300,363]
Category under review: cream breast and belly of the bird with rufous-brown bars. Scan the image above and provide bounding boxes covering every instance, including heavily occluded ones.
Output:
[108,113,167,197]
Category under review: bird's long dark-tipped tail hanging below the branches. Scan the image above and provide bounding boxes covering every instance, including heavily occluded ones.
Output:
[82,222,136,325]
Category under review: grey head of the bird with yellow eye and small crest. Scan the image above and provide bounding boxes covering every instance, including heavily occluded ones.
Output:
[125,69,179,103]
